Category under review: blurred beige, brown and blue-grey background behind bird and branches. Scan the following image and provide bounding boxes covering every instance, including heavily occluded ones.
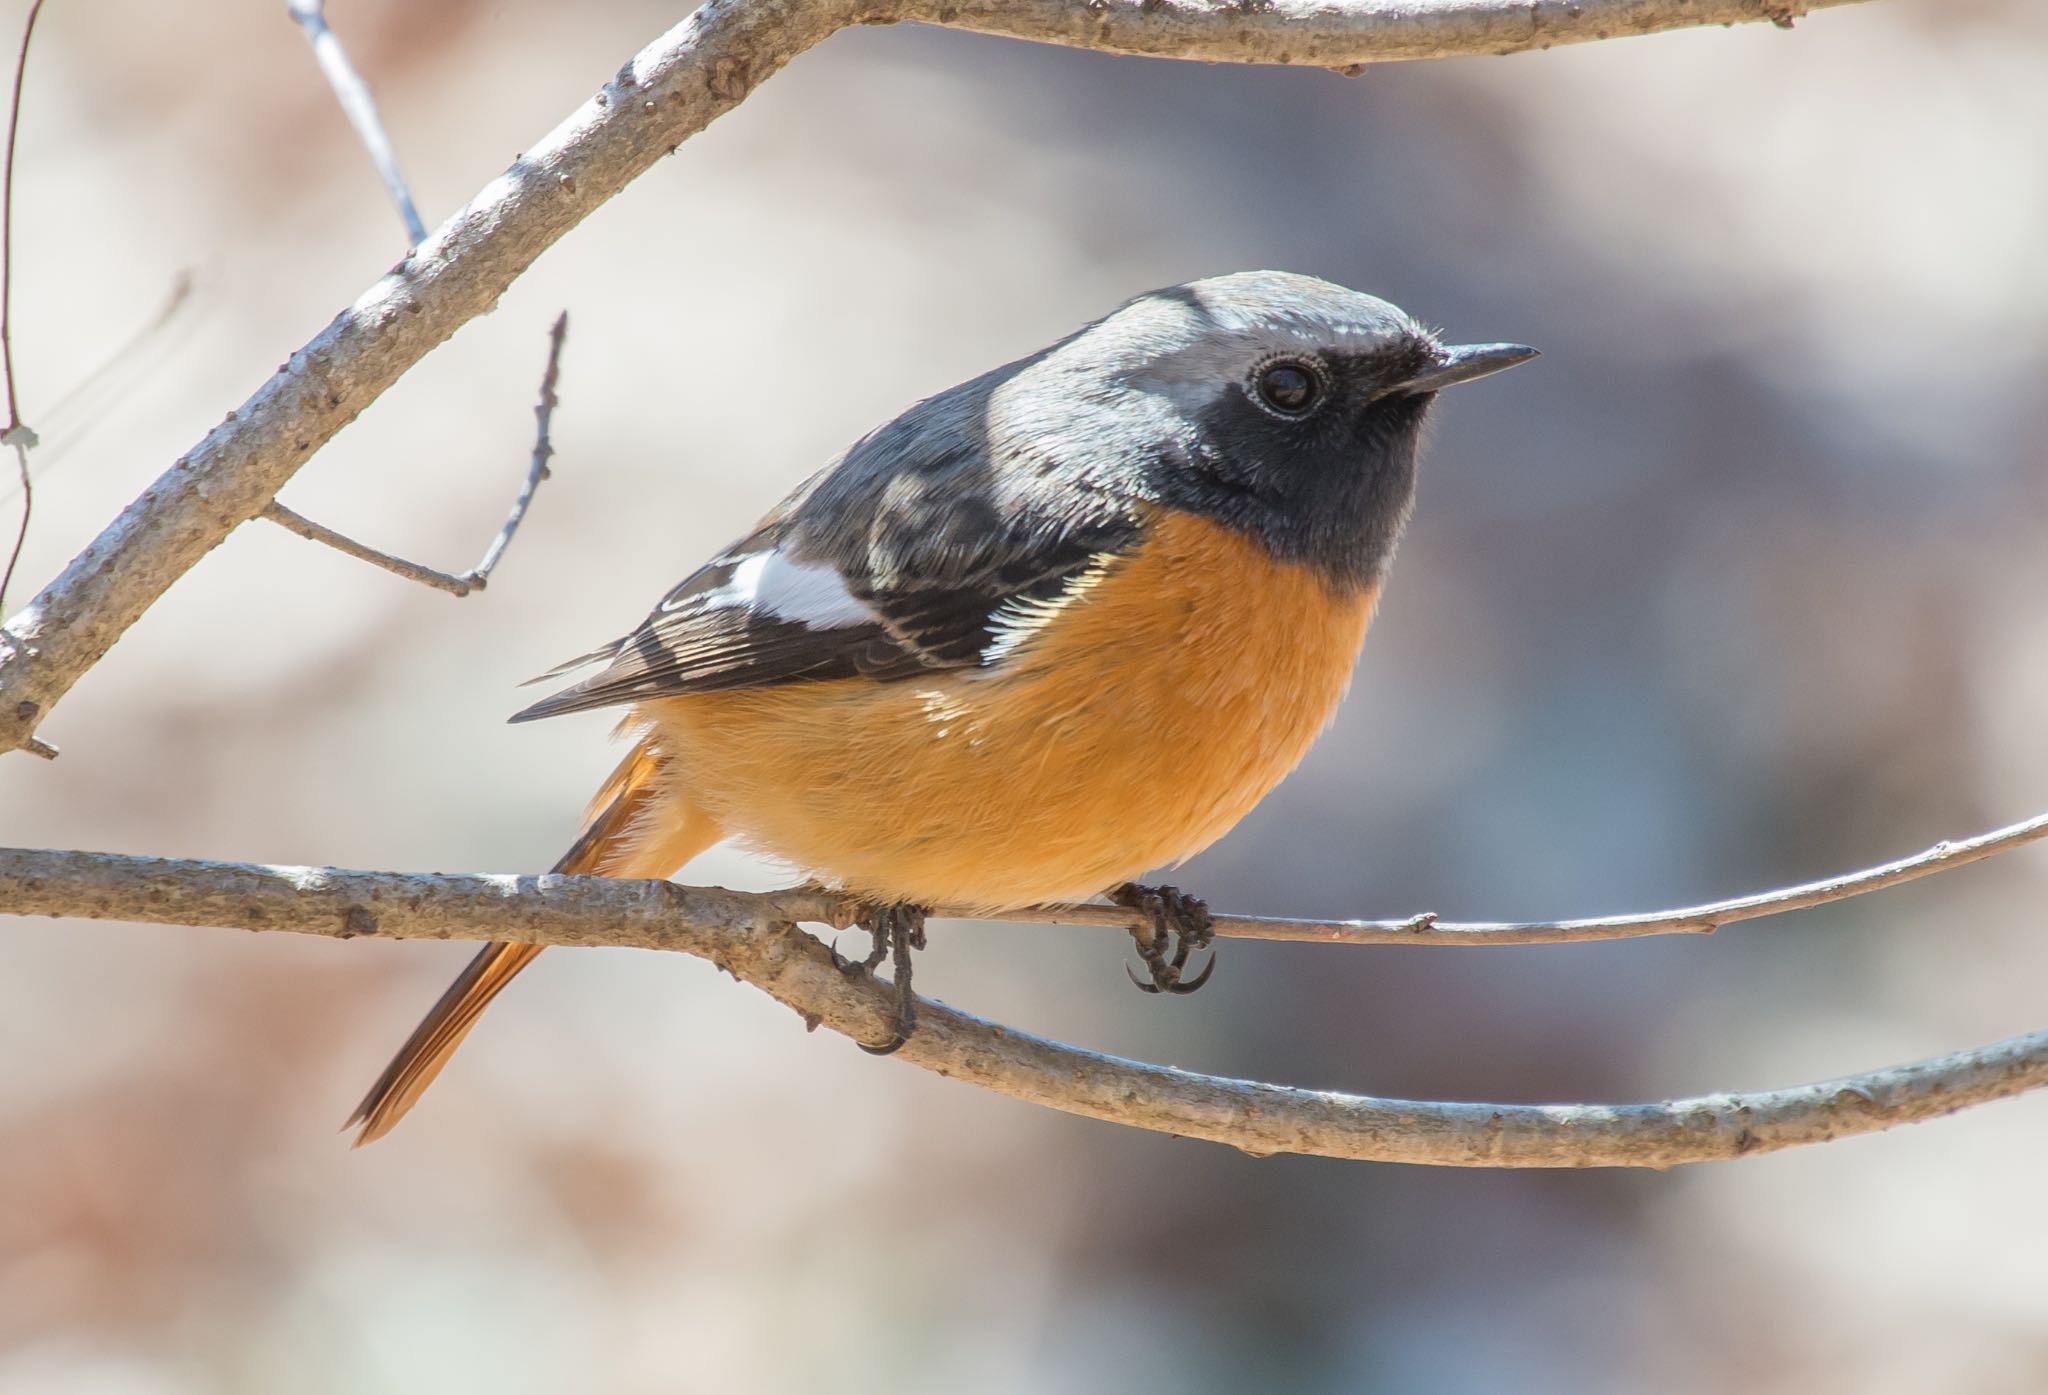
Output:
[0,0,2048,1395]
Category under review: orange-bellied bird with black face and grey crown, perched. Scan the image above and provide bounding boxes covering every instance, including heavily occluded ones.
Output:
[348,270,1536,1143]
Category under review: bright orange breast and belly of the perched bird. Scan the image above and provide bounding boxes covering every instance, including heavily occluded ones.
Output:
[637,514,1374,910]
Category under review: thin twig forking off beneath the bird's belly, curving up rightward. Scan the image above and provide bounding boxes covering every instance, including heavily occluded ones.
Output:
[987,813,2048,944]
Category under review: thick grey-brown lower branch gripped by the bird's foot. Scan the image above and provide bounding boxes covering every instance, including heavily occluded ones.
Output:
[0,850,2048,1168]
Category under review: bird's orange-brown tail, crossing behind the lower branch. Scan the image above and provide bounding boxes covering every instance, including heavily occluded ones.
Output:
[342,739,723,1147]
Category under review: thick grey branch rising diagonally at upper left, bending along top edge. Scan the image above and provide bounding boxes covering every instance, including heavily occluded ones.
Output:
[0,0,1862,752]
